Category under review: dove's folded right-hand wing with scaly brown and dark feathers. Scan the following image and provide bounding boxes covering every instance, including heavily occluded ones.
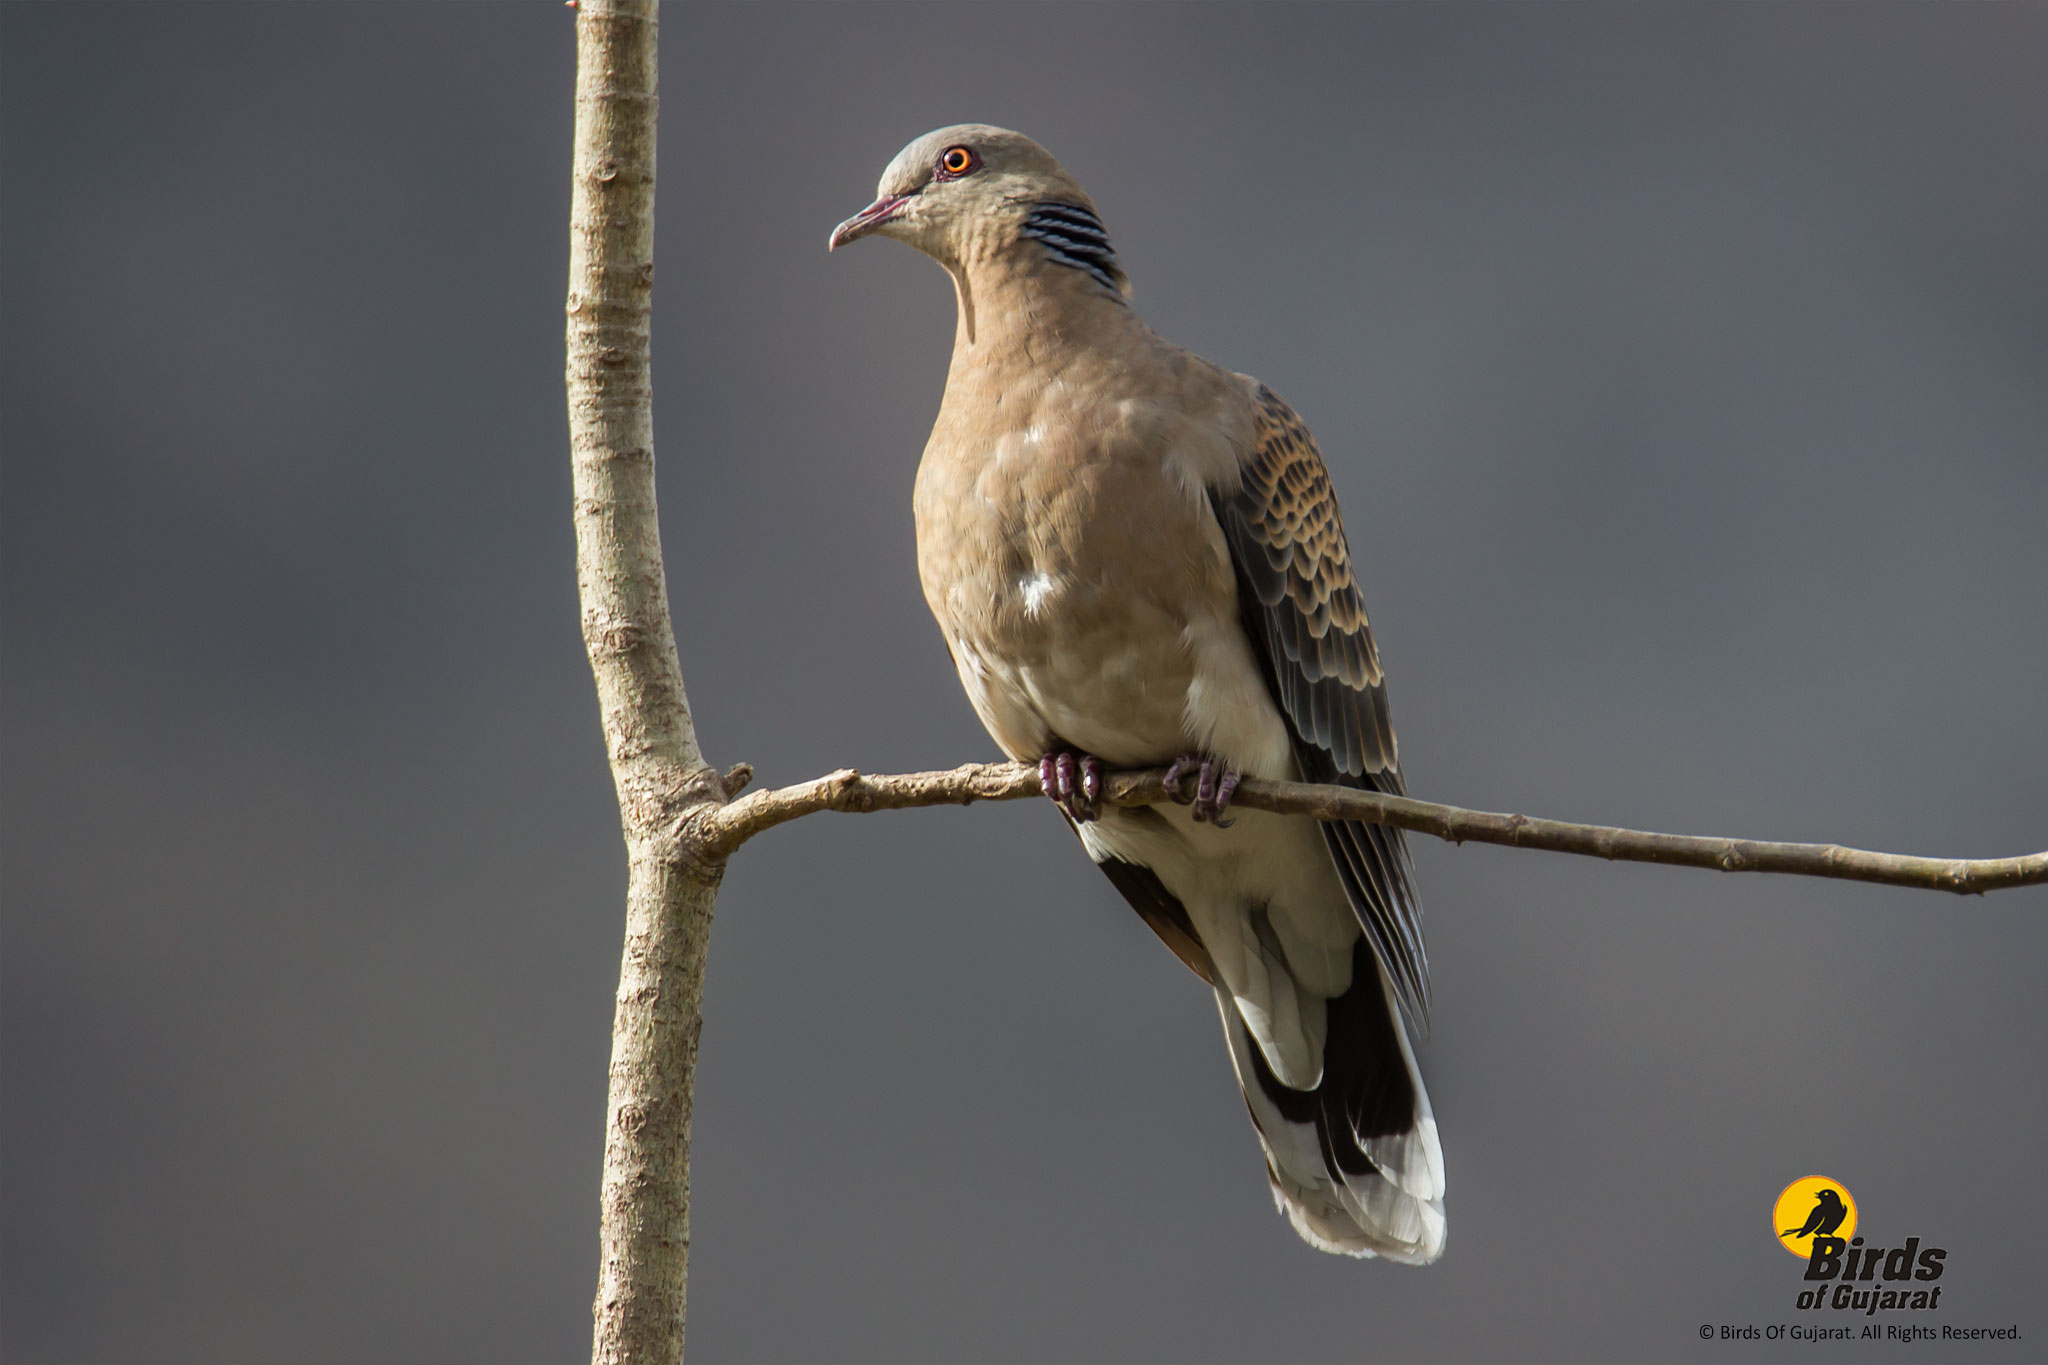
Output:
[1210,385,1430,1027]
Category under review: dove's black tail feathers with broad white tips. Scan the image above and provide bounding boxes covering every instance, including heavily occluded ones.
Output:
[1217,937,1444,1265]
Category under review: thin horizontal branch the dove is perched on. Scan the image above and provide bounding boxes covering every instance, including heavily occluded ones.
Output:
[702,763,2048,894]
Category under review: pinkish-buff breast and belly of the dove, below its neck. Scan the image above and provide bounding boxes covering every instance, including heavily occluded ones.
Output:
[915,374,1290,776]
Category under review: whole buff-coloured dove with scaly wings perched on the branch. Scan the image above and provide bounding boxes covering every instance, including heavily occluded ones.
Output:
[831,123,1444,1265]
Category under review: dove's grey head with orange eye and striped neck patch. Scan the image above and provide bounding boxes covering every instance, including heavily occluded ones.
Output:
[827,123,1130,297]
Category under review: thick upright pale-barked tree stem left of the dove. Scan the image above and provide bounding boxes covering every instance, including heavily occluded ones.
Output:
[567,0,725,1361]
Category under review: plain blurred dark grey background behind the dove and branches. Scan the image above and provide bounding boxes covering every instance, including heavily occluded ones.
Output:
[0,4,2048,1361]
